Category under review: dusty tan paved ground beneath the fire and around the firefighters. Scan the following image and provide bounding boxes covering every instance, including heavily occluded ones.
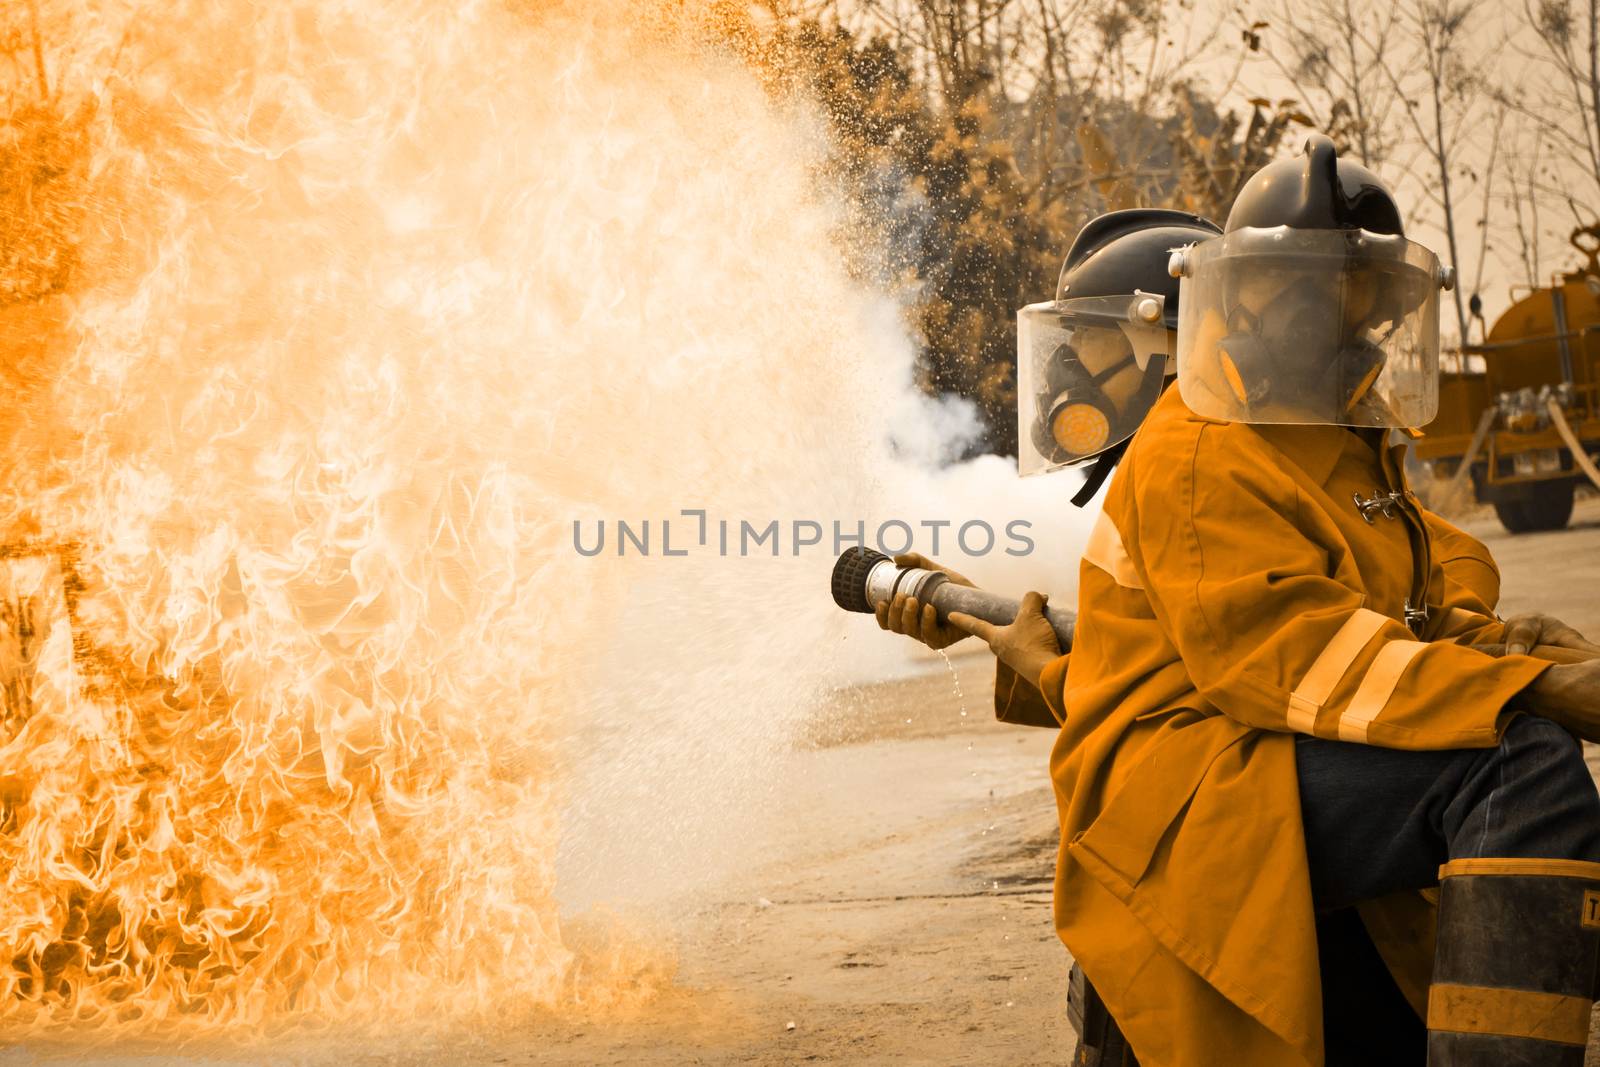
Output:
[12,498,1600,1067]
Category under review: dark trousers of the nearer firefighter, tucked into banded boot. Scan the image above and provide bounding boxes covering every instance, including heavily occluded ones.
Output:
[1296,715,1600,1067]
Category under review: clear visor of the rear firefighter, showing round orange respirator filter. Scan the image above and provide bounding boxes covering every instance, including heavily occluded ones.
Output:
[1016,293,1168,475]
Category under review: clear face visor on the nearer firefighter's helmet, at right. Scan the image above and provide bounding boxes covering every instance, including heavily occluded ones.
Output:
[1178,227,1442,427]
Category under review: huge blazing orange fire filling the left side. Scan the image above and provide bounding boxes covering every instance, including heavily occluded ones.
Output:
[0,0,915,1037]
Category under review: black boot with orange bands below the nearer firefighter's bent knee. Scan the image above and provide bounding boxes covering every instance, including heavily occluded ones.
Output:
[1427,859,1600,1067]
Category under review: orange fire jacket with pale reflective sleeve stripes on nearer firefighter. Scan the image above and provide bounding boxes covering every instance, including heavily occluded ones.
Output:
[1024,389,1549,1067]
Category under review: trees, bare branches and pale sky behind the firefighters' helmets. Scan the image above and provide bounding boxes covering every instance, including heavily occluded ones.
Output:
[747,0,1600,453]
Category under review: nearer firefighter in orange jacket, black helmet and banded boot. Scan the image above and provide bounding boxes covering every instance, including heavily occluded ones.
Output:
[880,138,1600,1067]
